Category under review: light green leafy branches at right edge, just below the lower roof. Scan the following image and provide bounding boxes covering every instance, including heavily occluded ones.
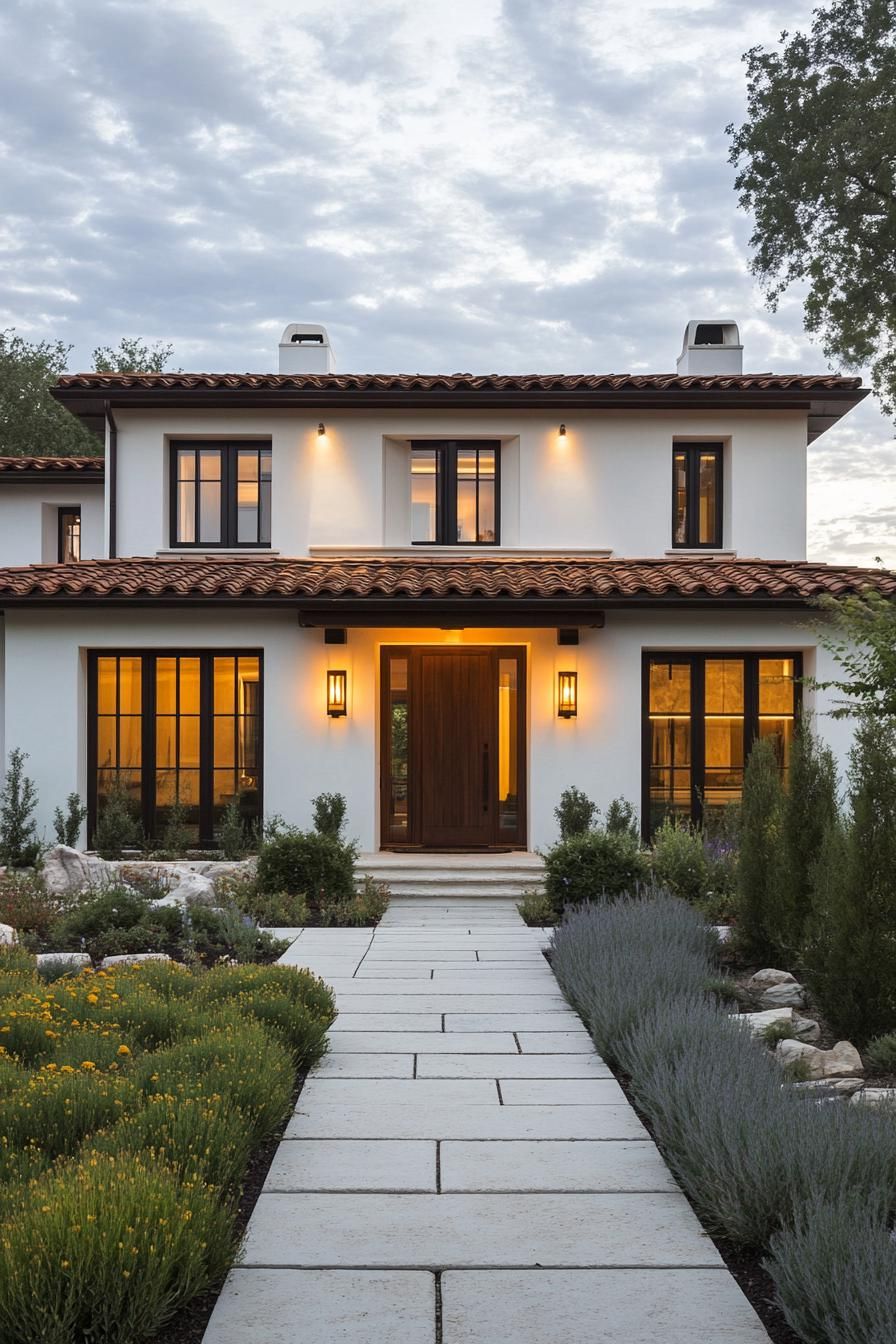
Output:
[814,589,896,719]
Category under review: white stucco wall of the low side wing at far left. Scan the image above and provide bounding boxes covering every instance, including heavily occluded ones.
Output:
[0,476,105,566]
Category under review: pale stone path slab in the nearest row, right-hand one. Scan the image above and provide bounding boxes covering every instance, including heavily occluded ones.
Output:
[442,1269,768,1344]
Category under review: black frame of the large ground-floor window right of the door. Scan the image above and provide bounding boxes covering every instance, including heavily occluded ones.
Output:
[641,649,803,843]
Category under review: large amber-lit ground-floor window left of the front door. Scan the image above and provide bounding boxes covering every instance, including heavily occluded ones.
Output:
[87,650,262,845]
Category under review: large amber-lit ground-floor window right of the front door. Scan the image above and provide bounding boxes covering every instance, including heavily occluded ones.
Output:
[642,653,802,836]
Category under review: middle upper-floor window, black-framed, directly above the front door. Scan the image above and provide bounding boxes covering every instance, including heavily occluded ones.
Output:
[411,441,501,546]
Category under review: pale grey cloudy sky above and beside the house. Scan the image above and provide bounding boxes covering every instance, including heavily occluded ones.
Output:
[0,0,896,564]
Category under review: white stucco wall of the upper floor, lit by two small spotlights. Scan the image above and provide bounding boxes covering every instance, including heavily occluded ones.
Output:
[108,410,806,559]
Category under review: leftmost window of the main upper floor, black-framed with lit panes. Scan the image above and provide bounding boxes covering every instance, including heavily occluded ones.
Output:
[171,441,271,546]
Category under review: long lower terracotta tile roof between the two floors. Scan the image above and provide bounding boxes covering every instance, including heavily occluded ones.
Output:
[0,555,896,607]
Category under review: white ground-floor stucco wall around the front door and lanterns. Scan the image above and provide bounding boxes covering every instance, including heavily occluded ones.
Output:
[0,610,850,849]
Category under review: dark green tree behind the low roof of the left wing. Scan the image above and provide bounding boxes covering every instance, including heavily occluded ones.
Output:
[0,328,102,457]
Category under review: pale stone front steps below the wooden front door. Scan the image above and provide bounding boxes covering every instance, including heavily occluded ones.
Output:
[357,852,544,900]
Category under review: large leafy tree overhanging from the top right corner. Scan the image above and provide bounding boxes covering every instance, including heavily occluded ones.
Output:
[727,0,896,415]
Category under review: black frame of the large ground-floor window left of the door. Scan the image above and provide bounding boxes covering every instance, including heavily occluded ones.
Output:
[86,645,265,849]
